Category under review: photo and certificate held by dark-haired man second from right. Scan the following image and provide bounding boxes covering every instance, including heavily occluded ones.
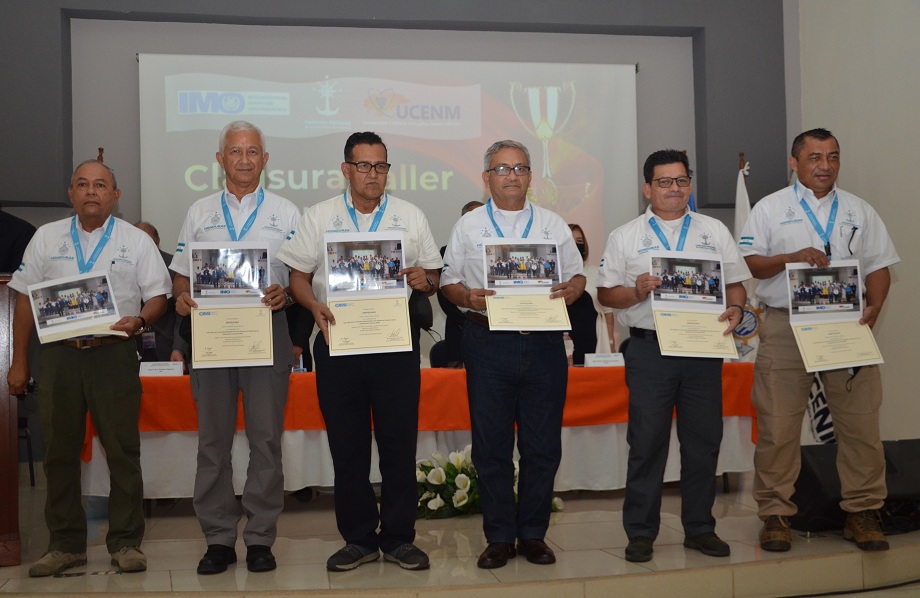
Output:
[649,251,738,359]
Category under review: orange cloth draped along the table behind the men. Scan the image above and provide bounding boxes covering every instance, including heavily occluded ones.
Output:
[84,363,756,457]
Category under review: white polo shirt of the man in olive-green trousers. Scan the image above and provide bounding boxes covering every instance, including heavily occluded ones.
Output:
[10,215,172,316]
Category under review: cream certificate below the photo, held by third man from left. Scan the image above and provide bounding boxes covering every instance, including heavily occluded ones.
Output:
[329,295,412,356]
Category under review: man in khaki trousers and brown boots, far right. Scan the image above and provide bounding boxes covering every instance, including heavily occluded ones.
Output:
[740,129,901,552]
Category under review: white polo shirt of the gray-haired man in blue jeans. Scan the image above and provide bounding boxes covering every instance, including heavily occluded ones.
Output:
[441,200,584,313]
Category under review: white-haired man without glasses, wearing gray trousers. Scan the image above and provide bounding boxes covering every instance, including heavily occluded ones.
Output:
[170,121,299,575]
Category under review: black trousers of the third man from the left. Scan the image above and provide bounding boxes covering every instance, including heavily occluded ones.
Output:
[313,334,421,552]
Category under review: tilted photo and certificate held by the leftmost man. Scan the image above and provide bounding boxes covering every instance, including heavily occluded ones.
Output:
[28,270,128,343]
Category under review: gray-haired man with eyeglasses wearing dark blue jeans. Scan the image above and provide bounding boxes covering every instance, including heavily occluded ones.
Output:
[442,140,585,569]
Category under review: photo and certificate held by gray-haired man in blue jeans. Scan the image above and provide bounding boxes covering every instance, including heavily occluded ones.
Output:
[482,238,572,331]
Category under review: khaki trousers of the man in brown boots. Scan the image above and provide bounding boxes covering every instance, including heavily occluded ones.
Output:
[752,307,888,519]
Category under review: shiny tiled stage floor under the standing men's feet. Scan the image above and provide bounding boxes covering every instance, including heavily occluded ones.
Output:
[0,470,920,598]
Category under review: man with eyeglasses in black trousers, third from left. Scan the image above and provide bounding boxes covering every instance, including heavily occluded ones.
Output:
[278,132,442,571]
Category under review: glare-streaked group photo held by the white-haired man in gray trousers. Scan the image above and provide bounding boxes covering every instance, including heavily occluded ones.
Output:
[186,241,271,308]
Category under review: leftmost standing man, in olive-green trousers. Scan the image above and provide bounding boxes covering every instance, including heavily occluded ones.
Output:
[7,160,170,577]
